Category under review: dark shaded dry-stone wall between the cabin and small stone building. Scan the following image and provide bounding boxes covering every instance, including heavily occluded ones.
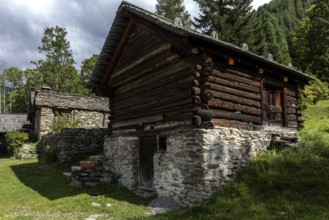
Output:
[41,128,108,162]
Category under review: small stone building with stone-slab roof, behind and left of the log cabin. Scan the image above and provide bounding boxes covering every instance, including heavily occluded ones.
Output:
[30,89,109,139]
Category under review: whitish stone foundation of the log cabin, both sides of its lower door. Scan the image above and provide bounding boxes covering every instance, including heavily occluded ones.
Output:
[104,127,298,207]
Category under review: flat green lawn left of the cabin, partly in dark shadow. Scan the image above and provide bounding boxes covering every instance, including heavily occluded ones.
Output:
[0,159,149,219]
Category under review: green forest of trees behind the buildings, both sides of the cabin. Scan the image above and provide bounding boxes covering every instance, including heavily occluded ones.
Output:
[0,0,329,113]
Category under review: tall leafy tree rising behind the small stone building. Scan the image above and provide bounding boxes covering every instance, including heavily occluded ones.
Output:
[32,26,78,92]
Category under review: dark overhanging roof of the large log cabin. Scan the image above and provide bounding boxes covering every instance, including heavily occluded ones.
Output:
[89,1,315,87]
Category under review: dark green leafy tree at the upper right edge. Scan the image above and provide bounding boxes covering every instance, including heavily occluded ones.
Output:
[290,0,329,82]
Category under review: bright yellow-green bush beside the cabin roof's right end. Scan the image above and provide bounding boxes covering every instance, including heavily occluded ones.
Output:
[301,80,329,109]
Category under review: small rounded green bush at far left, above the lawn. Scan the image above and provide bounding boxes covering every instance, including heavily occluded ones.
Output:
[5,131,29,157]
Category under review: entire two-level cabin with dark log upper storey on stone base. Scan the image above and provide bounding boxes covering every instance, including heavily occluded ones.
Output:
[90,2,312,206]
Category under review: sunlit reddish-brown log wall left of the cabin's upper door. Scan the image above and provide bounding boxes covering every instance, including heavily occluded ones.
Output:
[193,57,262,129]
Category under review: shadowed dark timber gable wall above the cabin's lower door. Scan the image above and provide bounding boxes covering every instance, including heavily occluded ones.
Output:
[109,27,193,128]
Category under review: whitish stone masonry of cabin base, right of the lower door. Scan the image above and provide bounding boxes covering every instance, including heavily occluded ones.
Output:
[154,128,296,206]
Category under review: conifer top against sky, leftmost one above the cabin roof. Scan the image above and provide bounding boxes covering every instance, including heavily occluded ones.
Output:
[155,0,190,26]
